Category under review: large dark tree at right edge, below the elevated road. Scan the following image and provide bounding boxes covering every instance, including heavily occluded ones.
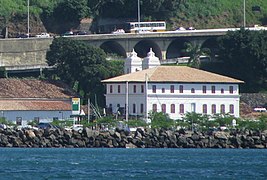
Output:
[218,28,267,92]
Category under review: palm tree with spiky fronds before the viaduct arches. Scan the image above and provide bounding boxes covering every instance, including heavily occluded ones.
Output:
[185,42,210,68]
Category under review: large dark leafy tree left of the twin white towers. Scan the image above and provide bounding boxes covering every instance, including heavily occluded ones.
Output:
[46,37,110,105]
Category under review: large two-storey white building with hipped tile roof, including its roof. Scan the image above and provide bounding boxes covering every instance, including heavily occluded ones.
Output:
[102,66,243,119]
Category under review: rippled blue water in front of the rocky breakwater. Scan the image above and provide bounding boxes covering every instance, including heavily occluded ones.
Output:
[0,148,267,180]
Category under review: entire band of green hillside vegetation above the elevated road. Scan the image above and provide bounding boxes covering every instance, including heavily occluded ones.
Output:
[0,0,267,33]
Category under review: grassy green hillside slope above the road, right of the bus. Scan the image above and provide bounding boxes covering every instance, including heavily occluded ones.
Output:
[171,0,267,29]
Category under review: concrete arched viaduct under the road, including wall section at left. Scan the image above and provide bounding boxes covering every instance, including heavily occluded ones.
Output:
[0,28,264,71]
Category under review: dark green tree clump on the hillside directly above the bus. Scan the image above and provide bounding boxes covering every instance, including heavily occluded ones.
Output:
[88,0,183,20]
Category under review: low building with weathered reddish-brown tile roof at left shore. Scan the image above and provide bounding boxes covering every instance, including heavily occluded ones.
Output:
[0,78,77,125]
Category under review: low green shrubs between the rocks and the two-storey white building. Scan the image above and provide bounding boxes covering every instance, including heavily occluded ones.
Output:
[63,112,267,131]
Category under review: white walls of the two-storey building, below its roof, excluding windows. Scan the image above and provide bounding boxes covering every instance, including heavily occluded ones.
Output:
[106,83,239,119]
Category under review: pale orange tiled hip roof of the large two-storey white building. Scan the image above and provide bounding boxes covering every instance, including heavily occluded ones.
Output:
[102,66,244,83]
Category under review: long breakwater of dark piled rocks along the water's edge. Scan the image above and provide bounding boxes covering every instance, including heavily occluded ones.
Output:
[0,128,267,148]
